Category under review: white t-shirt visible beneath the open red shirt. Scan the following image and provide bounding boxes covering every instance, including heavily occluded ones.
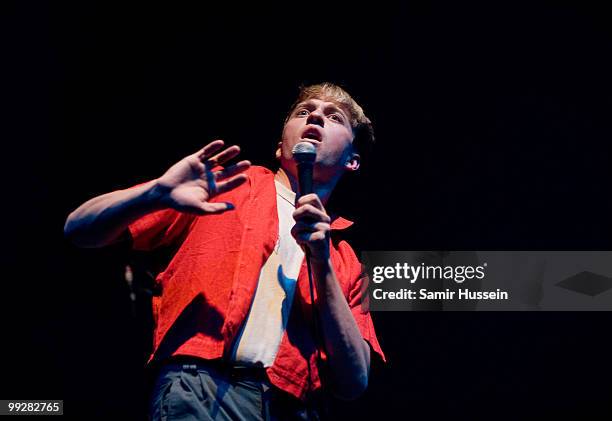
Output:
[233,180,304,367]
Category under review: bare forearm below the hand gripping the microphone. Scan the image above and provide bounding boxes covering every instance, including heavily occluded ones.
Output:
[312,259,370,399]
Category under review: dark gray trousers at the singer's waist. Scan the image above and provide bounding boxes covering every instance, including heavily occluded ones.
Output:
[150,359,319,421]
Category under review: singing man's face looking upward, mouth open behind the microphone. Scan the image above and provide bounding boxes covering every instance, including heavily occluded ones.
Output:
[277,98,359,182]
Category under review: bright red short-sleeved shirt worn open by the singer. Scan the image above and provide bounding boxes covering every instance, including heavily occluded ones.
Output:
[129,167,385,399]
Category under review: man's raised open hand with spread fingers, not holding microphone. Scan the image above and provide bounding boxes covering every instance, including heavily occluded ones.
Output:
[157,140,251,215]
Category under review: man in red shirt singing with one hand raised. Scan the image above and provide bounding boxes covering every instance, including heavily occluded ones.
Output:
[65,83,384,420]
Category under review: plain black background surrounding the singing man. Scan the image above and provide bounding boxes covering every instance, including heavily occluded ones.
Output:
[0,2,612,419]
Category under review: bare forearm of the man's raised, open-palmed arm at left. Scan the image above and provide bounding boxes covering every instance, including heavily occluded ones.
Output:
[64,180,162,247]
